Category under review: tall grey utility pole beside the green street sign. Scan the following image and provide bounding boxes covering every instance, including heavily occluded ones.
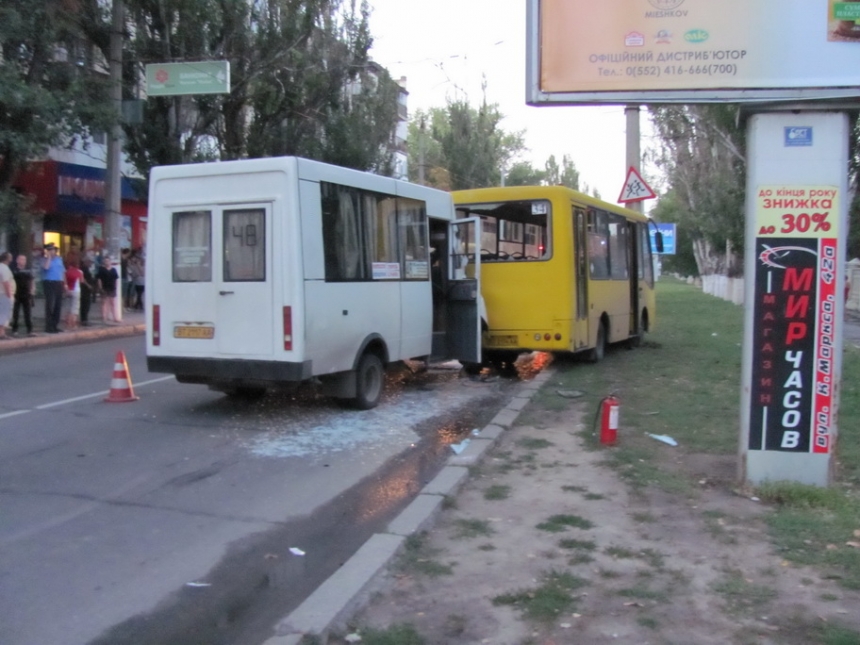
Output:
[104,0,125,320]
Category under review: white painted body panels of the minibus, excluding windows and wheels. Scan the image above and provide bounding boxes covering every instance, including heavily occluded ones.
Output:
[146,157,466,392]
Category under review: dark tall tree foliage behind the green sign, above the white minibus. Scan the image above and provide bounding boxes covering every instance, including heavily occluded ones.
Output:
[119,0,399,174]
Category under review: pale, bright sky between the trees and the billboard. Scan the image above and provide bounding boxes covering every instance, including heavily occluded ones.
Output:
[368,0,657,202]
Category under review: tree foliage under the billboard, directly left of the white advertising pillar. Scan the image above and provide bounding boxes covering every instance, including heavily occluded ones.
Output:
[649,104,746,275]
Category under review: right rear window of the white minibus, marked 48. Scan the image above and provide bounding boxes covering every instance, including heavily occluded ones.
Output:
[223,208,266,282]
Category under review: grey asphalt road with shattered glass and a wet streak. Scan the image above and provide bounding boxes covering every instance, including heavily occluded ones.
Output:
[0,336,512,645]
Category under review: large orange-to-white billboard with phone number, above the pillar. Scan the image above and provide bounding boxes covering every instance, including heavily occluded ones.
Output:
[527,0,860,105]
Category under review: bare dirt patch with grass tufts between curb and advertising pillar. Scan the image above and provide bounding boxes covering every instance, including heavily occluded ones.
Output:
[340,406,860,645]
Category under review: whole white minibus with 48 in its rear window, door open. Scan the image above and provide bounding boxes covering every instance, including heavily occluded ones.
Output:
[146,157,481,409]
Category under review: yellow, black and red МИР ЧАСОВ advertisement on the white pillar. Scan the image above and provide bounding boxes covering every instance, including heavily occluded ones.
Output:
[748,185,840,455]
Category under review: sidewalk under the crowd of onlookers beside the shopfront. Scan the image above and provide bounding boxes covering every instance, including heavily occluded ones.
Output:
[0,298,146,355]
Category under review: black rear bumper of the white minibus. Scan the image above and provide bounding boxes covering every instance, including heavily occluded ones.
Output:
[146,356,313,383]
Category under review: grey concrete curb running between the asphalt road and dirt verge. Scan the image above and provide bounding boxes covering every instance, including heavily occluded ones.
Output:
[263,368,552,645]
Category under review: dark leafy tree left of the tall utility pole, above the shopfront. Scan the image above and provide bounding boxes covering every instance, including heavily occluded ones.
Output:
[0,0,111,253]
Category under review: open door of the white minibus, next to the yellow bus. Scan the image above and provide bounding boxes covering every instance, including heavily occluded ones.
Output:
[446,217,483,363]
